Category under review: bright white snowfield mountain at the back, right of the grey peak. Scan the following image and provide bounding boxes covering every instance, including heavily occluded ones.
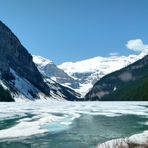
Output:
[58,53,146,94]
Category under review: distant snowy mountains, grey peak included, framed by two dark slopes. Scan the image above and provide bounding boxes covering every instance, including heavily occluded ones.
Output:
[33,53,146,96]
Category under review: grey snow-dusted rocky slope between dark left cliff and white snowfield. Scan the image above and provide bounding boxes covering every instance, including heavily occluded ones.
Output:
[33,56,81,101]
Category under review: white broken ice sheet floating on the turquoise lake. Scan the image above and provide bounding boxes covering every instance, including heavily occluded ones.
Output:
[0,101,148,140]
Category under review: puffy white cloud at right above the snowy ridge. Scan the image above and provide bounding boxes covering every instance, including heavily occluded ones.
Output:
[126,39,148,52]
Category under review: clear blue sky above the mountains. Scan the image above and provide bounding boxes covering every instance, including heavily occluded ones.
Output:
[0,0,148,64]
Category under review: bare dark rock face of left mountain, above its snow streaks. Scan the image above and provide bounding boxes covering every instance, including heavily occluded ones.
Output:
[0,21,50,94]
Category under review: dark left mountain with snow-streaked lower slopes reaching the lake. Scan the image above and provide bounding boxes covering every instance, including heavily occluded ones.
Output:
[0,21,80,101]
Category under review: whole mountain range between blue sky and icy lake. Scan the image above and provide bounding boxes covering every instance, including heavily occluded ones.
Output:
[0,22,148,102]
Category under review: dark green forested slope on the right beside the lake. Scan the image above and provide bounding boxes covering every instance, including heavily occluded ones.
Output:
[86,55,148,101]
